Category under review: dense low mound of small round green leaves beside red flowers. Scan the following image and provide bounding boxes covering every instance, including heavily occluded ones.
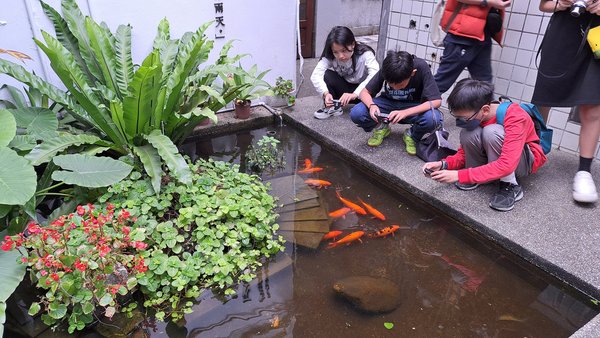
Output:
[100,160,283,320]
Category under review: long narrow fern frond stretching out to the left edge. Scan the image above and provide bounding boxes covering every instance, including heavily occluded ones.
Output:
[0,59,94,129]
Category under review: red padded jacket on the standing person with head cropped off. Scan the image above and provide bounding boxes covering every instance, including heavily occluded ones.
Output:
[441,0,504,45]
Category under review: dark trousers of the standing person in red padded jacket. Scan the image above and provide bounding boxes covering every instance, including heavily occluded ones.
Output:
[433,34,492,93]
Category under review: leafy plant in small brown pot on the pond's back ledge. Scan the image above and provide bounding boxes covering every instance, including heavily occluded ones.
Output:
[223,65,273,119]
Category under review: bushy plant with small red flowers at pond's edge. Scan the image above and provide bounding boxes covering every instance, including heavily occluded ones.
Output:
[2,204,147,333]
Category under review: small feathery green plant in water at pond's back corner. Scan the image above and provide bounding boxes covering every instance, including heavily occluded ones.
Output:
[246,136,285,173]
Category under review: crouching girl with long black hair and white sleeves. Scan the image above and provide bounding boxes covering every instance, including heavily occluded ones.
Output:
[310,26,379,119]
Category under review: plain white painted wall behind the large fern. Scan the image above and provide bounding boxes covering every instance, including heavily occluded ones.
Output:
[0,0,297,97]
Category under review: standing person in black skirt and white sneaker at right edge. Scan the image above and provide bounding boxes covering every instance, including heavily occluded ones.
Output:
[531,0,600,203]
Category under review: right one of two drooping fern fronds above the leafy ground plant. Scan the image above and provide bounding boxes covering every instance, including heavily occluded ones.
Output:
[145,130,192,184]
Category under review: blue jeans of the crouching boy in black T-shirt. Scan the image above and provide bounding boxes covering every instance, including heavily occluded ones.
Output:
[350,96,442,141]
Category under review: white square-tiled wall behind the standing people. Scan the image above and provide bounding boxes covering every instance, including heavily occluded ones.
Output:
[379,0,600,159]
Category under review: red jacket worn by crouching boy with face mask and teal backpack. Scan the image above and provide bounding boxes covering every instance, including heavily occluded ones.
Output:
[445,104,546,184]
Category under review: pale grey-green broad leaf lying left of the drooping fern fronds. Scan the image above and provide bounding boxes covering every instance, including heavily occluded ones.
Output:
[52,154,133,188]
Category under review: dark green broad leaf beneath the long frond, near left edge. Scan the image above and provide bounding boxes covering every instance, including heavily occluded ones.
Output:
[10,107,58,140]
